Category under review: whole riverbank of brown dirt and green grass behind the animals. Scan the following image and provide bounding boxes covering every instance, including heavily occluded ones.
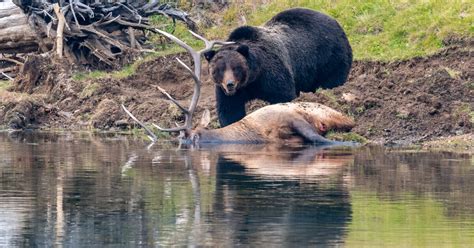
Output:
[0,0,474,149]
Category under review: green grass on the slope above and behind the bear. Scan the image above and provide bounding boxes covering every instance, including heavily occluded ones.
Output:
[207,0,474,60]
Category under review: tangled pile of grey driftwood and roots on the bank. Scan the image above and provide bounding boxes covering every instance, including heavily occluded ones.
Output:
[0,0,196,70]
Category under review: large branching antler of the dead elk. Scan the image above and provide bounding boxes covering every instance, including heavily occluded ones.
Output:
[122,29,234,142]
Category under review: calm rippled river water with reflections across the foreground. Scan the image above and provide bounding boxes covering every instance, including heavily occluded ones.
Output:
[0,133,474,247]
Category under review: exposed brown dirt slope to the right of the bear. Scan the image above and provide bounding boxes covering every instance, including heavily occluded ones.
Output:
[300,38,474,144]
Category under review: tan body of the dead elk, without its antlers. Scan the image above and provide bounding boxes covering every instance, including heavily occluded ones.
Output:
[190,102,354,143]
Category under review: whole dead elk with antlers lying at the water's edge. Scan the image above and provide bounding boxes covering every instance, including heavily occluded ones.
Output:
[122,30,354,144]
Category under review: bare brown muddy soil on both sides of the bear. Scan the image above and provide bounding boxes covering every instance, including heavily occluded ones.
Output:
[0,38,474,144]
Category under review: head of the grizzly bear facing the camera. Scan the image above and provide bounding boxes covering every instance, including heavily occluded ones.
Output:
[204,44,250,96]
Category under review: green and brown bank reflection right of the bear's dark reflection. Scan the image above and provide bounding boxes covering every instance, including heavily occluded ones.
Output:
[346,147,474,247]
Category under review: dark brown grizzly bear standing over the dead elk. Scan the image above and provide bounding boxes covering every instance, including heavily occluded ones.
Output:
[204,8,352,127]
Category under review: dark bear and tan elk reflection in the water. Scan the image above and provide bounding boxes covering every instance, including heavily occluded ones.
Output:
[206,145,353,246]
